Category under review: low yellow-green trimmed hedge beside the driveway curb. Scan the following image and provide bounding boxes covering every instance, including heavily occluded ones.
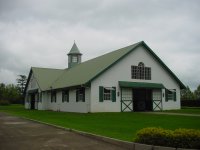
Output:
[135,127,200,149]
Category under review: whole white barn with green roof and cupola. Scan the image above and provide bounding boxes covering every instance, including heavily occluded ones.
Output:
[25,41,185,113]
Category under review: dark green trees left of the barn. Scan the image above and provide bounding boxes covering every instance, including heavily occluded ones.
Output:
[0,75,27,105]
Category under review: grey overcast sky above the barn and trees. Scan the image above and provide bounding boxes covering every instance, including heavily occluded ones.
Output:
[0,0,200,89]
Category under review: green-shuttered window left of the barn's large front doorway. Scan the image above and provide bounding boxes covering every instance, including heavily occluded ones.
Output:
[99,86,116,102]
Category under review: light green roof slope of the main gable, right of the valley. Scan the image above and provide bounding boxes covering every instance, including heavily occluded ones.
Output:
[52,43,140,89]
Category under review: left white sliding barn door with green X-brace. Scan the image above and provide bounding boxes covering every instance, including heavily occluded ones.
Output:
[121,88,133,112]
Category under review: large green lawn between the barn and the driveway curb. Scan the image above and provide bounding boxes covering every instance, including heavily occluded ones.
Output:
[0,105,200,141]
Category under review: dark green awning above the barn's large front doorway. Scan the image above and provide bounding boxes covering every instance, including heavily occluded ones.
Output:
[119,81,165,89]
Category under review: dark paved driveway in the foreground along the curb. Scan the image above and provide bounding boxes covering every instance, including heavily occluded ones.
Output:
[0,112,127,150]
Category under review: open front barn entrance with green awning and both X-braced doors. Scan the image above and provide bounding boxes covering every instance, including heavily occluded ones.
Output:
[119,81,165,112]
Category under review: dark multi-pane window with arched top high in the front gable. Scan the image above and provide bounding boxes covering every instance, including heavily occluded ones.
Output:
[131,62,151,80]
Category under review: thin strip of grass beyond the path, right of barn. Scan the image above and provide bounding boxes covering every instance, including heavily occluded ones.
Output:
[166,107,200,115]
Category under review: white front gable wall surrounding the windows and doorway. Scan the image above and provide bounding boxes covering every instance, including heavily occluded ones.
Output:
[91,46,180,112]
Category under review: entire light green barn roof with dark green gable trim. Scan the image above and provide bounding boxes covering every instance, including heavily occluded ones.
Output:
[25,41,185,90]
